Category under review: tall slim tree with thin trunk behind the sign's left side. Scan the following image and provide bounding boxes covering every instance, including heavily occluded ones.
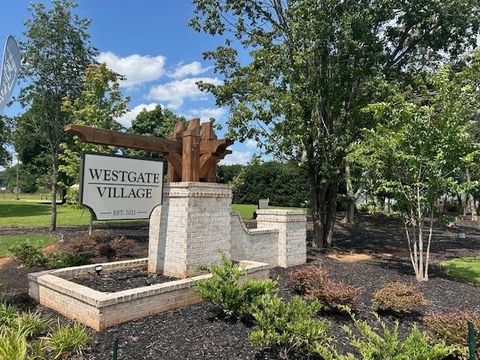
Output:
[19,0,96,231]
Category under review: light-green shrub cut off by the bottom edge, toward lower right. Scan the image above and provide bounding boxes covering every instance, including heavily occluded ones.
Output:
[340,315,456,360]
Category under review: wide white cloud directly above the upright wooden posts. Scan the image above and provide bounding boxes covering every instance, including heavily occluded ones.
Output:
[148,77,222,110]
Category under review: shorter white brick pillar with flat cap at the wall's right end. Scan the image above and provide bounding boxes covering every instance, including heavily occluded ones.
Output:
[257,209,307,267]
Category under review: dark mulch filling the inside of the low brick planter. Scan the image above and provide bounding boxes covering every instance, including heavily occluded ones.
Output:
[68,269,178,292]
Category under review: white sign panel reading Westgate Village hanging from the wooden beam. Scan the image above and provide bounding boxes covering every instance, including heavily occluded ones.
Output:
[80,154,163,220]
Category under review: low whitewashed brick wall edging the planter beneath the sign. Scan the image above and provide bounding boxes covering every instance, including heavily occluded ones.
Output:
[28,259,270,330]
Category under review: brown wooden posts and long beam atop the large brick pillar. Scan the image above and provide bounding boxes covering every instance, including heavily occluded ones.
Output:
[65,119,233,182]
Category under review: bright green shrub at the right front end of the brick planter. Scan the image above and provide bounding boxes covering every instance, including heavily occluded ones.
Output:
[196,256,277,319]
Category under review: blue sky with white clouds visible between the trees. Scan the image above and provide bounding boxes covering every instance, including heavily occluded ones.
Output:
[0,0,258,163]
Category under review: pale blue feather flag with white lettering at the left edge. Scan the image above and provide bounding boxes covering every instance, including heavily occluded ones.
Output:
[0,35,22,113]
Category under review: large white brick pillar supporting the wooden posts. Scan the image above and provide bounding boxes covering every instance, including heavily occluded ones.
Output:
[148,182,232,278]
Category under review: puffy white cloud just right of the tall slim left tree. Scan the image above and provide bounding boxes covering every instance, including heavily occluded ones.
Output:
[97,51,166,87]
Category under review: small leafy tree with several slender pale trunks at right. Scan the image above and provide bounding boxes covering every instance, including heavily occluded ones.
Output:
[351,51,480,281]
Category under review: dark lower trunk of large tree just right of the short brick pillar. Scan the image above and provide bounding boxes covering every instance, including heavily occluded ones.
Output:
[310,174,338,249]
